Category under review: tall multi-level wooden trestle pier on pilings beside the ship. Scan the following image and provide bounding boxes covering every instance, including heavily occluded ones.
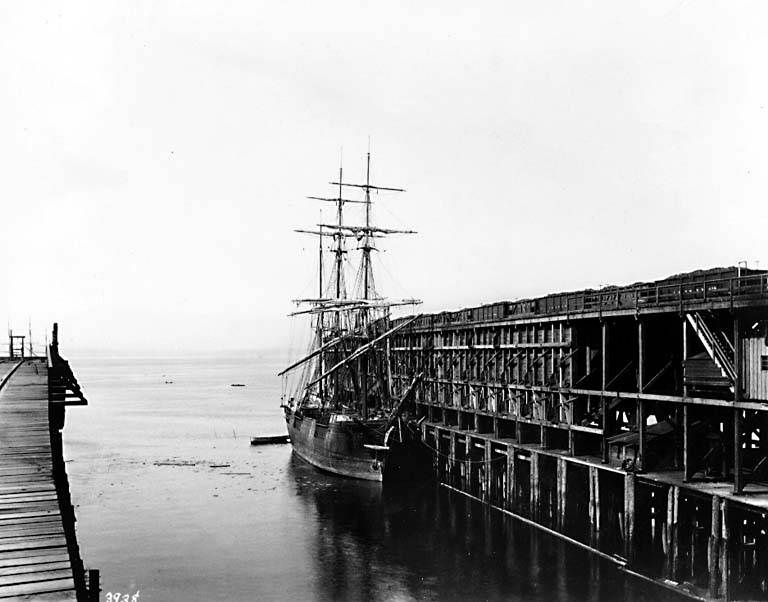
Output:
[389,268,768,600]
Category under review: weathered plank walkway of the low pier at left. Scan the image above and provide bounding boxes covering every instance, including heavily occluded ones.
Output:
[0,358,82,601]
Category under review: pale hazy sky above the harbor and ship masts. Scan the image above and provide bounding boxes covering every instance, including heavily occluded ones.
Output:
[0,0,768,351]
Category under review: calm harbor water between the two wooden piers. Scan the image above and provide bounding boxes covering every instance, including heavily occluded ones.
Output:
[64,355,680,602]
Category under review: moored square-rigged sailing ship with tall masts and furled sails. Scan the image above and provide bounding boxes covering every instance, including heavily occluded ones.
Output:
[279,153,421,481]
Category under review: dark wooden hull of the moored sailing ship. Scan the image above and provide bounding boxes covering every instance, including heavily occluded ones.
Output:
[285,408,387,481]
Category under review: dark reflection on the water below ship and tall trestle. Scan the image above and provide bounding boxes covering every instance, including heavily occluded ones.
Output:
[288,456,679,602]
